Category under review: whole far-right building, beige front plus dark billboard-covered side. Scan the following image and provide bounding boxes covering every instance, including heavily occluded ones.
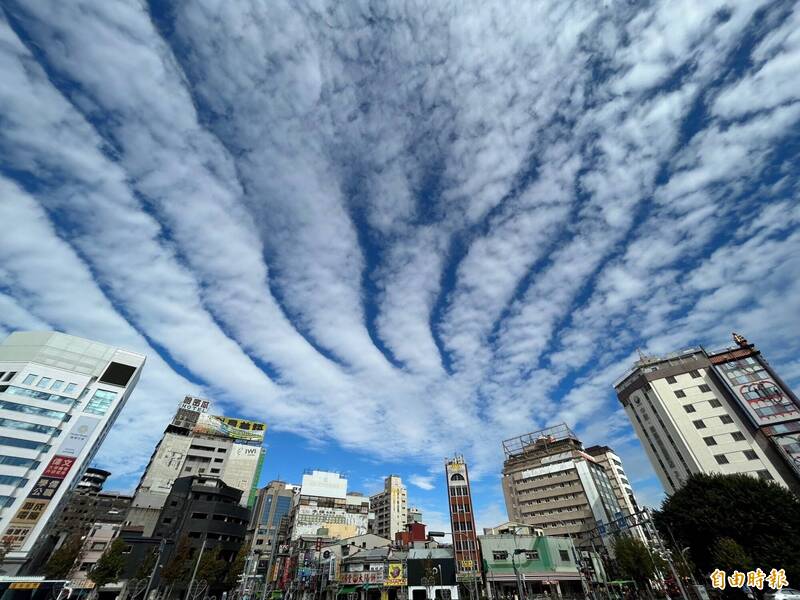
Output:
[614,336,800,493]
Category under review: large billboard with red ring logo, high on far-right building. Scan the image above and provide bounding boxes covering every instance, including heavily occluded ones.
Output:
[714,355,800,427]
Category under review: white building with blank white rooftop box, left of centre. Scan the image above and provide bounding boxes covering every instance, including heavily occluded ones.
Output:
[290,471,370,540]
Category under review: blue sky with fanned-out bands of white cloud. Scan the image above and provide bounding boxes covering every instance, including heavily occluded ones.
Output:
[0,0,800,530]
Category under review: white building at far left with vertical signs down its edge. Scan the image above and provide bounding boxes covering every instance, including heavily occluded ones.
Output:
[0,331,145,574]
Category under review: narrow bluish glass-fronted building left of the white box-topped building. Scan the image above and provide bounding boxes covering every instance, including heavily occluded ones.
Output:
[249,481,300,574]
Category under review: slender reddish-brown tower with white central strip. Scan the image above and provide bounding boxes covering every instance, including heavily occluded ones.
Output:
[444,455,481,576]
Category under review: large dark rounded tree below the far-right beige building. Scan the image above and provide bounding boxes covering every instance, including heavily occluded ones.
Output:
[655,474,800,581]
